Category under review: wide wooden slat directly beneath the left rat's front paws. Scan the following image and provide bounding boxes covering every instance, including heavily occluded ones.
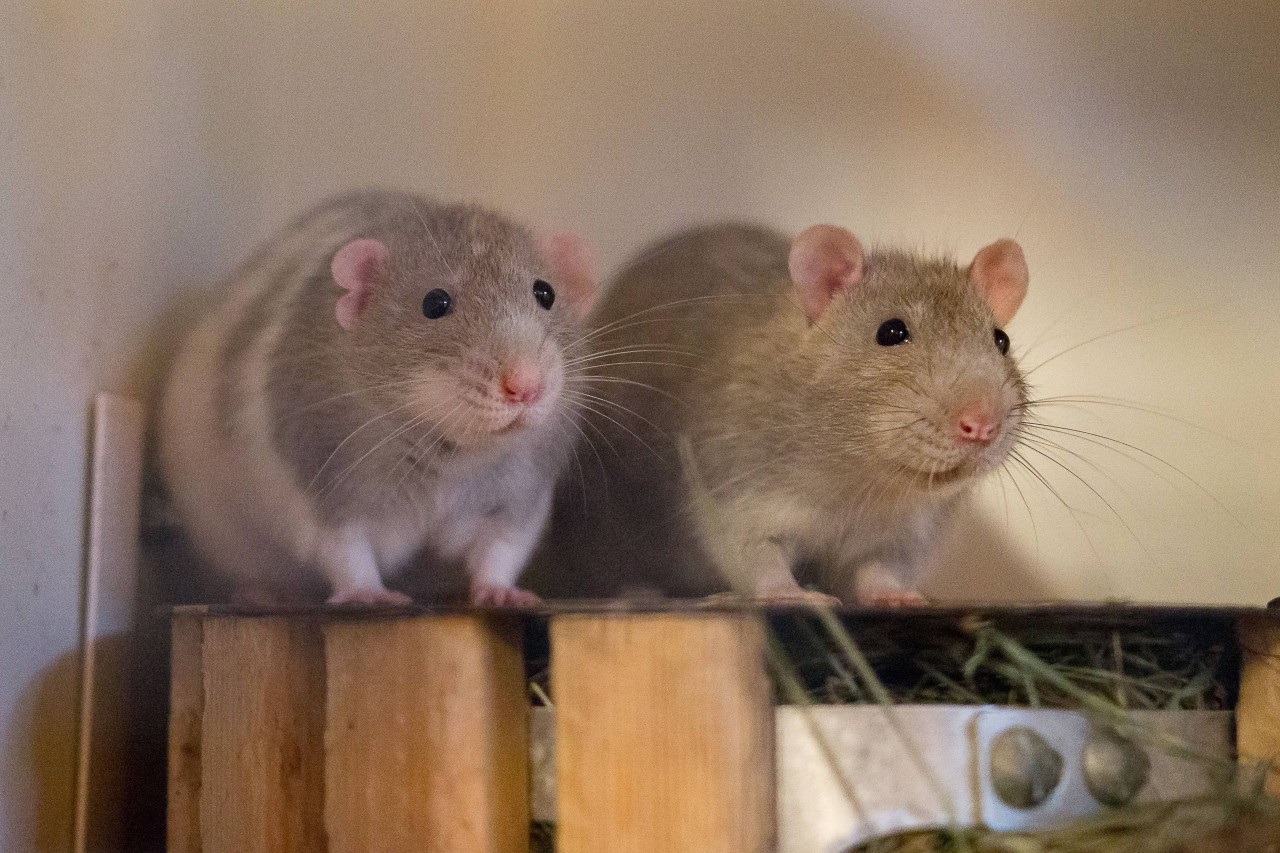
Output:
[325,615,529,853]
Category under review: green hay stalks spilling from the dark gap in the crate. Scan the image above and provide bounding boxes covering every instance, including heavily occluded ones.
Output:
[530,601,1280,853]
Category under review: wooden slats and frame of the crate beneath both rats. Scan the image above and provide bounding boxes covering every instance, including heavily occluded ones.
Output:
[168,605,1280,853]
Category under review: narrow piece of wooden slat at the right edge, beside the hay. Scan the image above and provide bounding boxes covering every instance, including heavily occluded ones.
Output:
[1235,616,1280,797]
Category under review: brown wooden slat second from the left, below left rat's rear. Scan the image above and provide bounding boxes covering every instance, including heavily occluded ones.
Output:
[200,617,325,853]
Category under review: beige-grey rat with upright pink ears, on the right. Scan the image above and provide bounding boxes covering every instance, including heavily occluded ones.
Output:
[539,225,1028,603]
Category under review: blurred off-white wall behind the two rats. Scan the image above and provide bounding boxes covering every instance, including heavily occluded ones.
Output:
[0,0,1280,853]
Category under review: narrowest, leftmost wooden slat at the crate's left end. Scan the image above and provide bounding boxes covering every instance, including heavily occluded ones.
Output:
[166,616,205,853]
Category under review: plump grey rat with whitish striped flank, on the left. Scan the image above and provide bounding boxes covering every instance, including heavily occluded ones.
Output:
[159,191,594,605]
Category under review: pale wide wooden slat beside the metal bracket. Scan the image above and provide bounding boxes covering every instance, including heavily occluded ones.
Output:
[552,613,776,853]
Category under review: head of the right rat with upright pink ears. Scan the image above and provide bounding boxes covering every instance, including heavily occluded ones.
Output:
[790,225,1028,493]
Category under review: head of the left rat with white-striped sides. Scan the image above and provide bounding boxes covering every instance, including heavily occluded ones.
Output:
[330,205,595,446]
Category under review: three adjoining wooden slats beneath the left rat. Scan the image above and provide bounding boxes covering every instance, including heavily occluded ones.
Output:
[168,610,529,853]
